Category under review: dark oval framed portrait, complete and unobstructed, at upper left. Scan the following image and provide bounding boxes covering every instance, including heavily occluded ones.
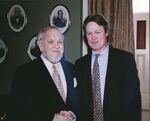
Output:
[7,4,27,32]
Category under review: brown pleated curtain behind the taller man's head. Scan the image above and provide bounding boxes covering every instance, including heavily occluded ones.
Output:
[88,0,134,54]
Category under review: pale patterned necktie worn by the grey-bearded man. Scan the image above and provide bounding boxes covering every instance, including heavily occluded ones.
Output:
[52,64,66,102]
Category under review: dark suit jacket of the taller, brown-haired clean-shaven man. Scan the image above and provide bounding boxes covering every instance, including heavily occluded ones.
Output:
[75,47,141,121]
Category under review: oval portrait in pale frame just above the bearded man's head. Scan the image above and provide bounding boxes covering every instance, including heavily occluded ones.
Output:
[49,5,71,33]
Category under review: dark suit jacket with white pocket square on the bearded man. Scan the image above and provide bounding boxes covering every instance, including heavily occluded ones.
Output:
[8,58,78,121]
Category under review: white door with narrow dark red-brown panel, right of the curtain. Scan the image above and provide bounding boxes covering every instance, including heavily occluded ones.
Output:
[134,12,150,121]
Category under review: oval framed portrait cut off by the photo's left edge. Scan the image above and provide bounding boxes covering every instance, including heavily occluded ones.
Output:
[0,39,8,63]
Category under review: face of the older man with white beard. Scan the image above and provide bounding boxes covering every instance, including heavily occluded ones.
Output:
[38,29,64,63]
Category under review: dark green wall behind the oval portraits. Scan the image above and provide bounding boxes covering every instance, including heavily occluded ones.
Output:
[0,0,82,94]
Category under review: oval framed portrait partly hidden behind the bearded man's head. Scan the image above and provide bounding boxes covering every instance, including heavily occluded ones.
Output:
[27,36,41,60]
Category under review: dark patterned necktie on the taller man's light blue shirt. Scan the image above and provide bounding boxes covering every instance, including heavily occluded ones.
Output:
[92,54,104,121]
